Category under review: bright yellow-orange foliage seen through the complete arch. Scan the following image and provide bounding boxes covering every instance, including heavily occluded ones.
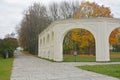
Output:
[71,29,95,47]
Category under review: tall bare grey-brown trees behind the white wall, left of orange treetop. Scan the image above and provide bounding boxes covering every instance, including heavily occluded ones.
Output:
[17,2,79,54]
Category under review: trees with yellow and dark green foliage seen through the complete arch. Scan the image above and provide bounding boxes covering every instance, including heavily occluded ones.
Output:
[64,29,95,53]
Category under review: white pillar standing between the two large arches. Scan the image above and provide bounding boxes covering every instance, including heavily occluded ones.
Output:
[95,26,110,61]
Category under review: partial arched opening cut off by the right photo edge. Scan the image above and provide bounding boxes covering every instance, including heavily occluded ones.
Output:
[109,27,120,62]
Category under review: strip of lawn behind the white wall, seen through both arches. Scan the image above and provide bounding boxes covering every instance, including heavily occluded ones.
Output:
[63,52,120,62]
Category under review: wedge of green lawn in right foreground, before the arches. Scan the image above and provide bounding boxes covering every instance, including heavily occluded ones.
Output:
[78,64,120,79]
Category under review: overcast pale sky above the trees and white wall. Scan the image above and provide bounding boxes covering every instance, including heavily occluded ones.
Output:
[0,0,120,38]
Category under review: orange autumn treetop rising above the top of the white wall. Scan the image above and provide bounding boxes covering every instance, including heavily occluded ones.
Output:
[74,1,113,18]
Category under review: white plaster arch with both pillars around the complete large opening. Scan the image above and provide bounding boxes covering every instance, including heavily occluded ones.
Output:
[54,21,109,61]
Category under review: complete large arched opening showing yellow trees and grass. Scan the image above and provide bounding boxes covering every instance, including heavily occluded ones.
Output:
[63,28,95,62]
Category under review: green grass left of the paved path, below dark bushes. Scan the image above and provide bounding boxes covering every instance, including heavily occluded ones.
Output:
[0,58,13,80]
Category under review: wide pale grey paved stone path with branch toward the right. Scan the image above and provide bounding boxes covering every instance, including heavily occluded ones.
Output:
[11,51,120,80]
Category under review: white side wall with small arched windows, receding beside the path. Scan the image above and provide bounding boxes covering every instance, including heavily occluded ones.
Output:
[38,25,54,59]
